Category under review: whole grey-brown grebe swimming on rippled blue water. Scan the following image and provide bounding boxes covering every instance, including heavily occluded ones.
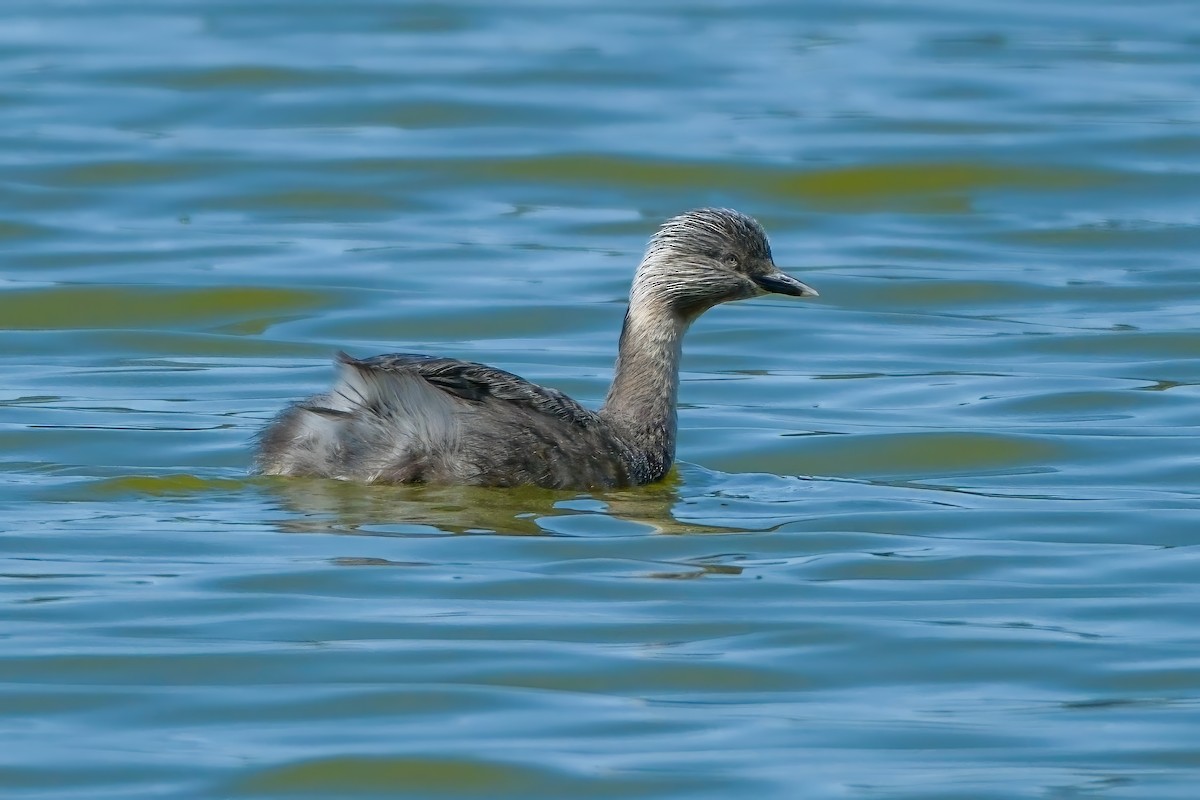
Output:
[256,207,818,491]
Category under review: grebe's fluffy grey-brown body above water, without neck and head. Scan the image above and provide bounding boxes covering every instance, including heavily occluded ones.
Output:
[260,354,648,488]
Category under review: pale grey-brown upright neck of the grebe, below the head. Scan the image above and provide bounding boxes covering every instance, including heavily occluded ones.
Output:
[600,293,690,480]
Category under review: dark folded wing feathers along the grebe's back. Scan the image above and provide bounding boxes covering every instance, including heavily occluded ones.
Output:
[337,353,596,427]
